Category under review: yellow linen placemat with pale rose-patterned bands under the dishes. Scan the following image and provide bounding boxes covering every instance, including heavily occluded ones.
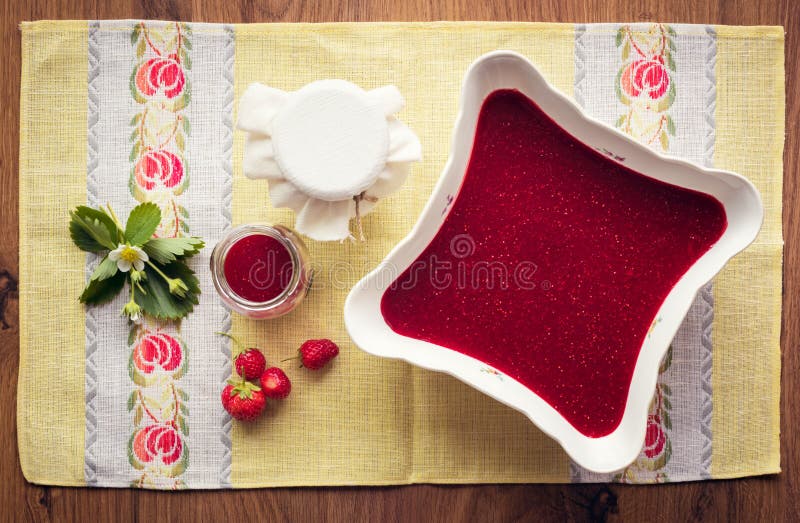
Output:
[18,21,784,488]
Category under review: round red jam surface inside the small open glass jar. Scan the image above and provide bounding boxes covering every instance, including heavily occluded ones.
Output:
[223,234,294,303]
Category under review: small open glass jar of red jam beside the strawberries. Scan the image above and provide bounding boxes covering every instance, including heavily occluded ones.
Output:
[211,224,313,319]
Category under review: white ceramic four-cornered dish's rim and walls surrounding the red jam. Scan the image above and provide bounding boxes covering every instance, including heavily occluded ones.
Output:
[344,51,763,472]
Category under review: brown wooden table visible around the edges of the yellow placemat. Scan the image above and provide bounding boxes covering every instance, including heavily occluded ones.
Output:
[0,0,800,521]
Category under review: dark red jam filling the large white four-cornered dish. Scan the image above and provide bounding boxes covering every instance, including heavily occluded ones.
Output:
[381,90,727,437]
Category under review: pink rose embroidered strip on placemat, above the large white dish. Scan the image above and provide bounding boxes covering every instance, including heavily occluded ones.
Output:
[614,24,676,151]
